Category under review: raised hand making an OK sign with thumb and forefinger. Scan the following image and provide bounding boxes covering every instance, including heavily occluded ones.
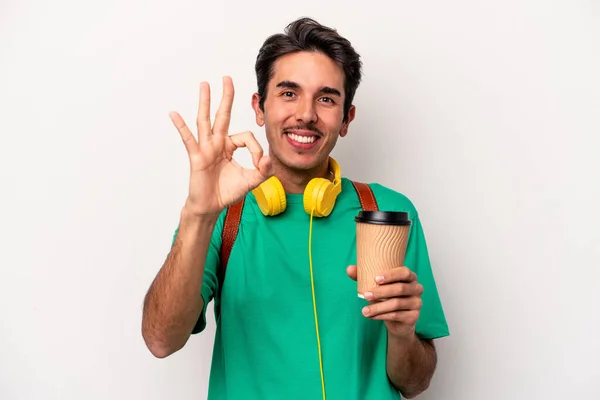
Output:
[170,77,272,216]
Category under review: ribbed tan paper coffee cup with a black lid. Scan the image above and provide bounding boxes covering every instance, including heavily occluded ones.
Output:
[354,211,411,298]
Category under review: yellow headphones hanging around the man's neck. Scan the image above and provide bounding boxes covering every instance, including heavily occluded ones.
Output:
[252,157,342,217]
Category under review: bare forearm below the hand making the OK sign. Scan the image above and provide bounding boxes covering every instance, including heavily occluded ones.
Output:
[142,208,216,358]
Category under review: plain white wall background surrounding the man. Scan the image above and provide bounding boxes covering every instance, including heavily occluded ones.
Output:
[0,0,600,400]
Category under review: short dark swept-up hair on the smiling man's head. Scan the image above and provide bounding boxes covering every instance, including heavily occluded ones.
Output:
[255,18,362,121]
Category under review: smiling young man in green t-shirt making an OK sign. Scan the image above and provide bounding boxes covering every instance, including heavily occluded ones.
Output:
[142,19,448,400]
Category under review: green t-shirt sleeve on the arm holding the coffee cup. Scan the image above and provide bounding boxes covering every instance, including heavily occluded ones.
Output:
[404,214,450,339]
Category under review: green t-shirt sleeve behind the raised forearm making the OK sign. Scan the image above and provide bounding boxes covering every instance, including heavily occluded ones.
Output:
[172,215,223,334]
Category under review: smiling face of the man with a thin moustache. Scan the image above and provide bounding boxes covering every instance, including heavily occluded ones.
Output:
[252,52,355,170]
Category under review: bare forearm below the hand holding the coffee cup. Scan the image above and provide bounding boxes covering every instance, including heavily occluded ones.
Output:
[387,334,437,398]
